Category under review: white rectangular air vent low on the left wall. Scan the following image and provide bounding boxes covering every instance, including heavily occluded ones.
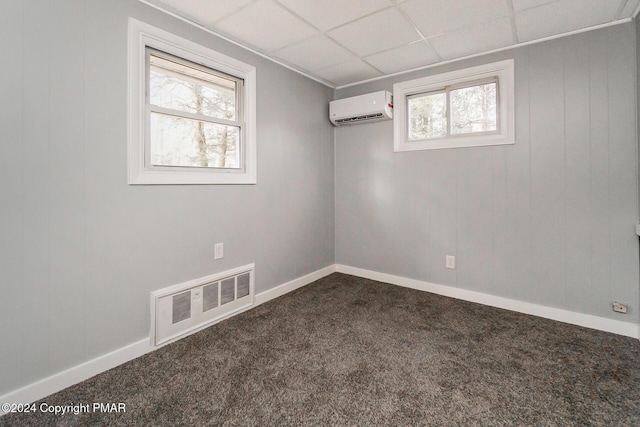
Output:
[151,264,254,346]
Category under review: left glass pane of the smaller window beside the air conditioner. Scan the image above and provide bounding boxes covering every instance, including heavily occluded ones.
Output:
[408,93,447,140]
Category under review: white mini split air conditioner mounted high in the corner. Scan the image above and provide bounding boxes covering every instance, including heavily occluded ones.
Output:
[329,90,393,126]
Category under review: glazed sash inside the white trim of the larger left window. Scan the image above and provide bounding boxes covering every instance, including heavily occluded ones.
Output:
[145,48,243,169]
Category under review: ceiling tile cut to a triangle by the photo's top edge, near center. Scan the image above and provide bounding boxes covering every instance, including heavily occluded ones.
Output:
[278,0,393,31]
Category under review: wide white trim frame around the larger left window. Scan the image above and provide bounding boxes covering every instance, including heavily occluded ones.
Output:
[128,18,257,185]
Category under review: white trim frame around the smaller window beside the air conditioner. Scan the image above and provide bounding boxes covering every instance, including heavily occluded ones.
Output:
[393,59,515,152]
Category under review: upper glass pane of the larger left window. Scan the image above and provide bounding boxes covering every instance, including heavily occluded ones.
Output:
[149,55,237,120]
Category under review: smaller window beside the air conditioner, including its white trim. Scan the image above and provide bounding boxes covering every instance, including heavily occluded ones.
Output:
[393,60,515,151]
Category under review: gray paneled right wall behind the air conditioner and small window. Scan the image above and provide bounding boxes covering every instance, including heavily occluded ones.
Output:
[335,23,639,323]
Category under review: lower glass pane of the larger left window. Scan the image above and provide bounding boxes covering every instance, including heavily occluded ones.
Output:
[149,113,241,169]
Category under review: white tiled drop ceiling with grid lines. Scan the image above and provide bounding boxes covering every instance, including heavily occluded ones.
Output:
[143,0,640,87]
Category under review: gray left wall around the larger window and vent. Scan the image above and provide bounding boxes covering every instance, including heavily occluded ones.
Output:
[0,0,334,395]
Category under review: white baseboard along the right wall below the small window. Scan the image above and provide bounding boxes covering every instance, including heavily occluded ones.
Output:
[335,264,640,339]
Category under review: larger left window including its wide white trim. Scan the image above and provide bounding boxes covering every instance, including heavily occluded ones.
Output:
[129,19,256,184]
